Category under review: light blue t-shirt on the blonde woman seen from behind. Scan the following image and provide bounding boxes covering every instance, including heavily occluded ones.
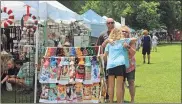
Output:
[105,38,131,70]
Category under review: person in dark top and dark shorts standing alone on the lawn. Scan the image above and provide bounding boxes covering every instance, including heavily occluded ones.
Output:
[141,30,152,64]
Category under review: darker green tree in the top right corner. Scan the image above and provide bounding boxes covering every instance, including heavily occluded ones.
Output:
[159,0,182,34]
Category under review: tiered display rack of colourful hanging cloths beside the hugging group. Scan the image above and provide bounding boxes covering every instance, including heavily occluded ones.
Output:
[39,47,106,103]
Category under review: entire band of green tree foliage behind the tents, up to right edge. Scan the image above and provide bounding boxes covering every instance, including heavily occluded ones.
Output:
[58,0,182,31]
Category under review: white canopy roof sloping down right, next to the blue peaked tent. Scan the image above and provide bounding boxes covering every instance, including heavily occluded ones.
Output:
[22,1,81,21]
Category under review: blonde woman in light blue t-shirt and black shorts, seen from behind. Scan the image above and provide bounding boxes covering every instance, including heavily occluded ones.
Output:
[104,28,136,103]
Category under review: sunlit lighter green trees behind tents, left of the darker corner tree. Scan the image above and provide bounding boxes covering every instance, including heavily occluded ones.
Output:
[81,1,160,29]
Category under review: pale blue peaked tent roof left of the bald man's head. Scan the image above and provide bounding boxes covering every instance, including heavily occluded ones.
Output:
[81,9,106,23]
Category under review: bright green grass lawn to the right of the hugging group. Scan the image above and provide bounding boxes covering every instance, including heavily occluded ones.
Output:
[115,44,181,103]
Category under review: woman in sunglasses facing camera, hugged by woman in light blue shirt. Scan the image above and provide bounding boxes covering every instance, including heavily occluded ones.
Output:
[121,26,138,103]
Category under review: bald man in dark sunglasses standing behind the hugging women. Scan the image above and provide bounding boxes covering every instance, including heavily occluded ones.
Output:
[96,18,114,102]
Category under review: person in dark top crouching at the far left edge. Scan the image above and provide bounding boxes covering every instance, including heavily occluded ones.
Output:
[1,59,19,90]
